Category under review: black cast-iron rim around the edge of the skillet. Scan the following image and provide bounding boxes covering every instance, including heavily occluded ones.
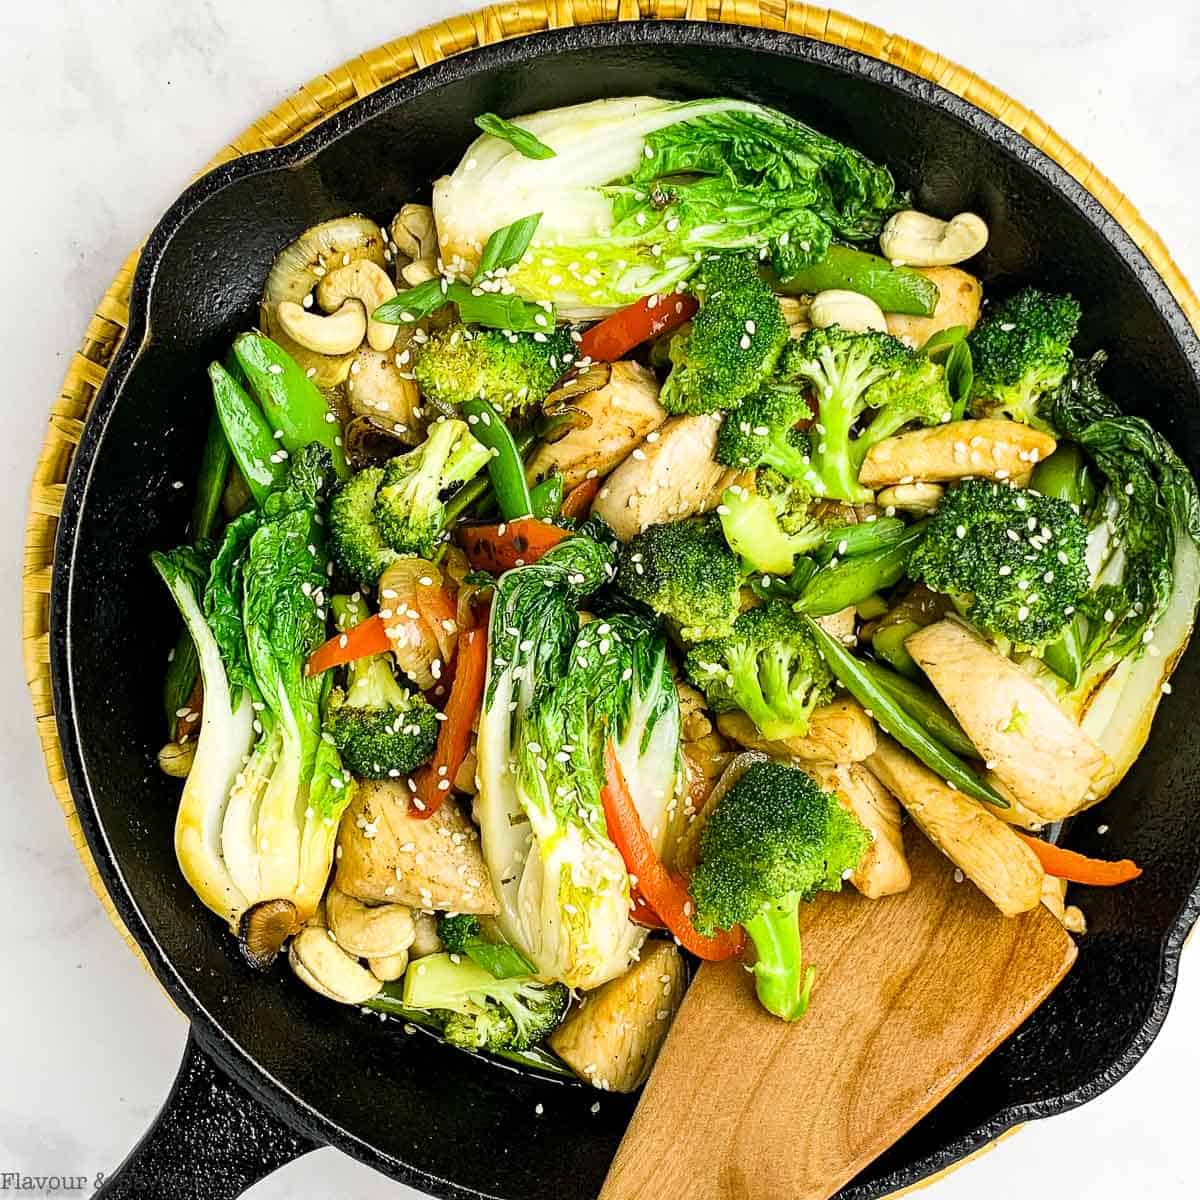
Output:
[50,20,1200,1196]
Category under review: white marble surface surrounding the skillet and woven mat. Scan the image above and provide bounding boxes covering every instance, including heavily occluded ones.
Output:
[0,0,1200,1200]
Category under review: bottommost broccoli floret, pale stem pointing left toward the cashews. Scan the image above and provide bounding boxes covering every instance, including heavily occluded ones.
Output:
[404,954,570,1050]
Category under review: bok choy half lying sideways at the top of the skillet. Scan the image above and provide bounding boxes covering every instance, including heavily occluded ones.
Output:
[433,97,904,317]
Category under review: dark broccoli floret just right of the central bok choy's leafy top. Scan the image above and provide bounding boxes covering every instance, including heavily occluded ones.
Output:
[617,517,742,641]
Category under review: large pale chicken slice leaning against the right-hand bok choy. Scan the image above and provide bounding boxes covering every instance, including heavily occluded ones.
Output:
[905,618,1114,821]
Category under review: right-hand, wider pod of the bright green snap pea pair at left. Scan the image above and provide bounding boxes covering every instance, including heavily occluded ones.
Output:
[233,334,350,479]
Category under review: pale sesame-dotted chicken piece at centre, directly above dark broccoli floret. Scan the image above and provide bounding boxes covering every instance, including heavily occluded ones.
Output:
[592,414,738,541]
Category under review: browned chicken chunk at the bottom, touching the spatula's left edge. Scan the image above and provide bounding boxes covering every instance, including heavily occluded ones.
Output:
[547,940,686,1092]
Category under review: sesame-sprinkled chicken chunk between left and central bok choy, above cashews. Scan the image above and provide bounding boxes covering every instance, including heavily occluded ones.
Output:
[337,780,500,916]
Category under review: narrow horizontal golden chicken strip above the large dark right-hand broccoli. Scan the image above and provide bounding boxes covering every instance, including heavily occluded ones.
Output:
[858,419,1057,488]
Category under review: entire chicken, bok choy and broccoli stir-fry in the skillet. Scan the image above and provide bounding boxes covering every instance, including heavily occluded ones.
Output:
[154,98,1200,1091]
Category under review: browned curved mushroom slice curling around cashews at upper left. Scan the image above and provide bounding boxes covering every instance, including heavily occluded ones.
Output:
[259,216,386,388]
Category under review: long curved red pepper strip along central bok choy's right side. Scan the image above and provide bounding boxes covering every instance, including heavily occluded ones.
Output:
[600,742,745,962]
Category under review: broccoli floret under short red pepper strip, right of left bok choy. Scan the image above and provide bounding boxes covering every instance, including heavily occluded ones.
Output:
[323,596,438,779]
